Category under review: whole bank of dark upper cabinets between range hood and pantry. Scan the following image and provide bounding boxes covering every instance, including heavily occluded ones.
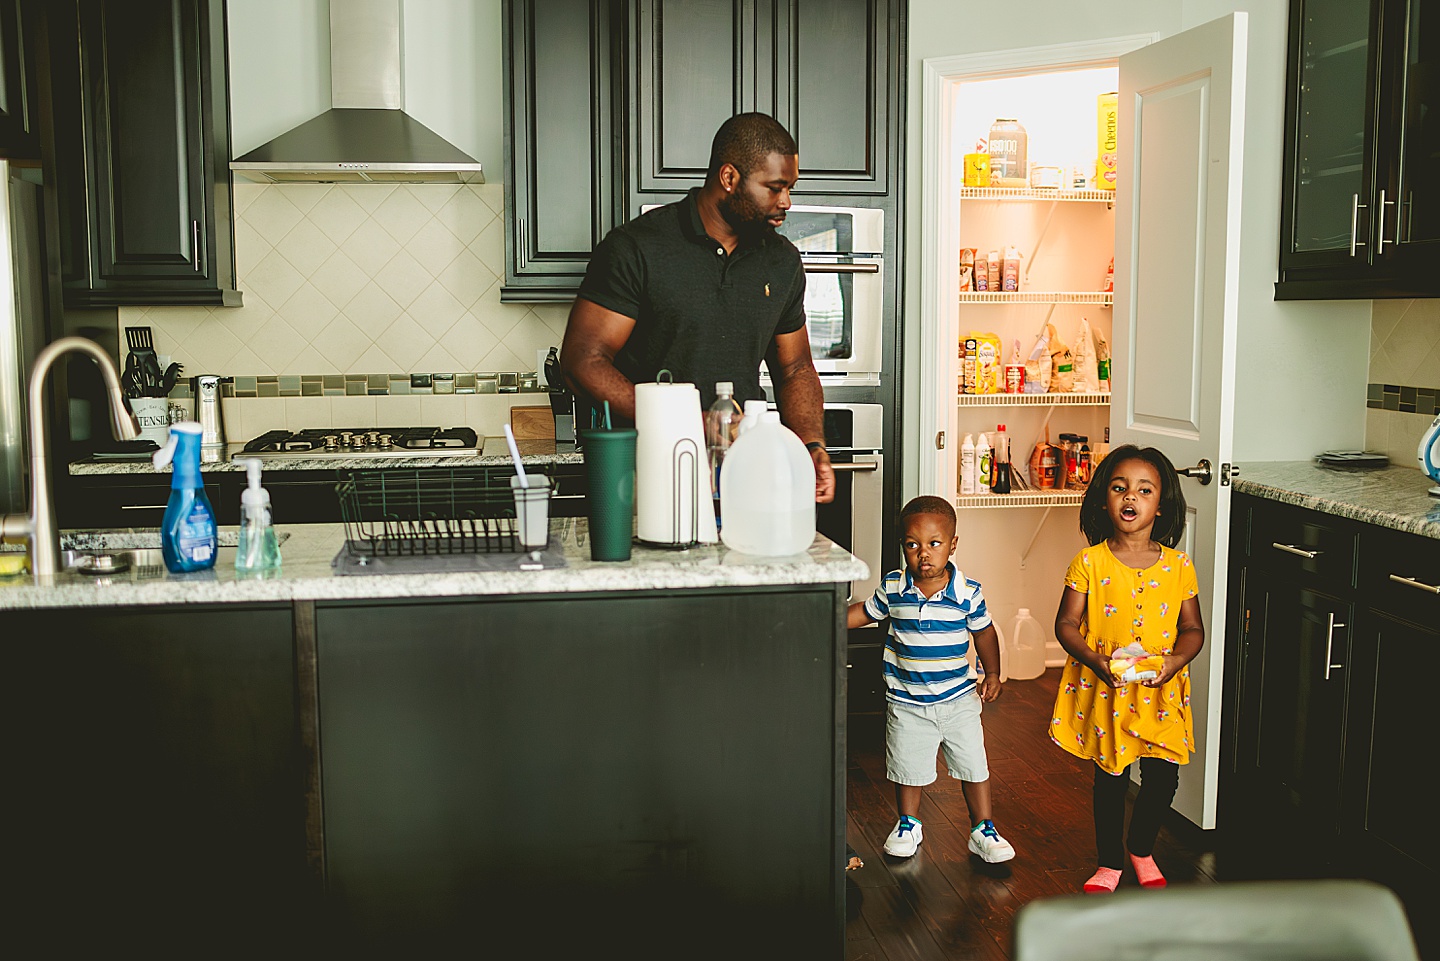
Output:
[501,0,904,300]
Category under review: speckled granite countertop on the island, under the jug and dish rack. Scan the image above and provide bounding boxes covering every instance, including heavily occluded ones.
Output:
[0,517,870,611]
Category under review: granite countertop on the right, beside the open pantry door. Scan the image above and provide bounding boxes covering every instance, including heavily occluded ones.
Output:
[1231,461,1440,539]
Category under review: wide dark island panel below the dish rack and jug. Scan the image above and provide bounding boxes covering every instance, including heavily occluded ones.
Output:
[317,585,845,958]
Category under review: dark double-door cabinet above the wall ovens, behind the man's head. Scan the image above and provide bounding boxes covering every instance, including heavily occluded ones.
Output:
[626,0,900,216]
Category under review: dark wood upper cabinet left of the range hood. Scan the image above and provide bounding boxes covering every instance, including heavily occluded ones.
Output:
[50,0,240,307]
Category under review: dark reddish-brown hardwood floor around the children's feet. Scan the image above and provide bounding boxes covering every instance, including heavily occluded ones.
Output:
[845,669,1215,961]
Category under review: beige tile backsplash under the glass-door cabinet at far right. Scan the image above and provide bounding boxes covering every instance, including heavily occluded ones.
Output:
[1365,300,1440,467]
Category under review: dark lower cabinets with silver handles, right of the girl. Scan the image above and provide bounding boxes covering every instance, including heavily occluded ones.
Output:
[1218,494,1440,944]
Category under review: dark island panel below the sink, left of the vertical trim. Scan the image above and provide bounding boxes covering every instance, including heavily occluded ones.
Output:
[0,605,306,957]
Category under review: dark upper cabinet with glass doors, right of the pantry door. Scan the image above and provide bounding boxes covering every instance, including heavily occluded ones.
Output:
[1276,0,1440,300]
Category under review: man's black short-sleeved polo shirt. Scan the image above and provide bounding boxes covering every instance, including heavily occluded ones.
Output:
[580,189,805,408]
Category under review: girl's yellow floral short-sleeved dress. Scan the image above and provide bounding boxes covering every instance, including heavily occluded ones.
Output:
[1050,542,1200,774]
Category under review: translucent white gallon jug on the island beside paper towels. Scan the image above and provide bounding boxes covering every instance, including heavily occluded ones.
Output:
[720,411,815,556]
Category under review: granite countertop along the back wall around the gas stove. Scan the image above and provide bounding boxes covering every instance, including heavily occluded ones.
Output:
[69,437,585,475]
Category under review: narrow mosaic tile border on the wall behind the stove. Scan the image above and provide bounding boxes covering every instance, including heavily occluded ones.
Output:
[170,370,546,398]
